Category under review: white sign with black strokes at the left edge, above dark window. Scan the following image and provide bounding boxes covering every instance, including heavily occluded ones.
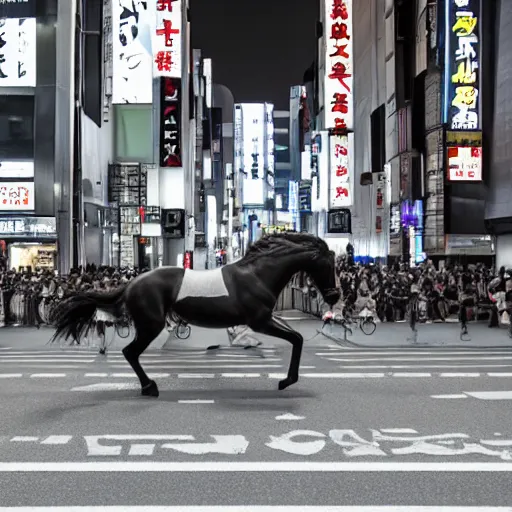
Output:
[0,18,36,87]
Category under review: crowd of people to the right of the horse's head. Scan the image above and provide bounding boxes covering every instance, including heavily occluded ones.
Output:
[337,256,512,327]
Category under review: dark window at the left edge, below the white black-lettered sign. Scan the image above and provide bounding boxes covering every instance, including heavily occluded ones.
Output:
[0,95,34,160]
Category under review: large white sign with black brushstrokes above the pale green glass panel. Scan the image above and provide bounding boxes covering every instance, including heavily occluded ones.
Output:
[112,0,155,103]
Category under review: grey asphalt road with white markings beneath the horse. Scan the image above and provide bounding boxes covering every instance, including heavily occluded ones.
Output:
[0,329,512,512]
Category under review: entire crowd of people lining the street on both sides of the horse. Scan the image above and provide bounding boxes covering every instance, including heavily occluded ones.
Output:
[0,255,512,334]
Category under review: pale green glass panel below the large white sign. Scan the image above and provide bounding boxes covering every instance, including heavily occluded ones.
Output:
[114,105,153,163]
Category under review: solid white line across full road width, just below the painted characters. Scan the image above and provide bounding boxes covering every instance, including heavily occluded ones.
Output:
[0,462,512,470]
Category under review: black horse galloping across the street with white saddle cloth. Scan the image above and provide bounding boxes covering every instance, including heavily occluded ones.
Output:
[52,233,340,397]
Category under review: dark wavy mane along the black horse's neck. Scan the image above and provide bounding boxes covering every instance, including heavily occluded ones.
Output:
[238,231,329,265]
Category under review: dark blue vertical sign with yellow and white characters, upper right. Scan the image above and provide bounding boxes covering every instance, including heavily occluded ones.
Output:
[445,0,482,130]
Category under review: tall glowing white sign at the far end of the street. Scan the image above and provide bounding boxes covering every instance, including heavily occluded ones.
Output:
[241,103,265,205]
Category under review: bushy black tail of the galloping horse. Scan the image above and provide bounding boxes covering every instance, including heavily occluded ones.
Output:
[50,287,125,343]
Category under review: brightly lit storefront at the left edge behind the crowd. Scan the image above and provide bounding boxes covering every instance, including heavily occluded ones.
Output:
[0,217,57,271]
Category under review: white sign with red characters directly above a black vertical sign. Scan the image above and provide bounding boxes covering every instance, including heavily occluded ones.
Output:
[153,0,182,78]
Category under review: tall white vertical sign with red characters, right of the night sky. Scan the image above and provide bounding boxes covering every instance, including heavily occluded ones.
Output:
[324,0,354,130]
